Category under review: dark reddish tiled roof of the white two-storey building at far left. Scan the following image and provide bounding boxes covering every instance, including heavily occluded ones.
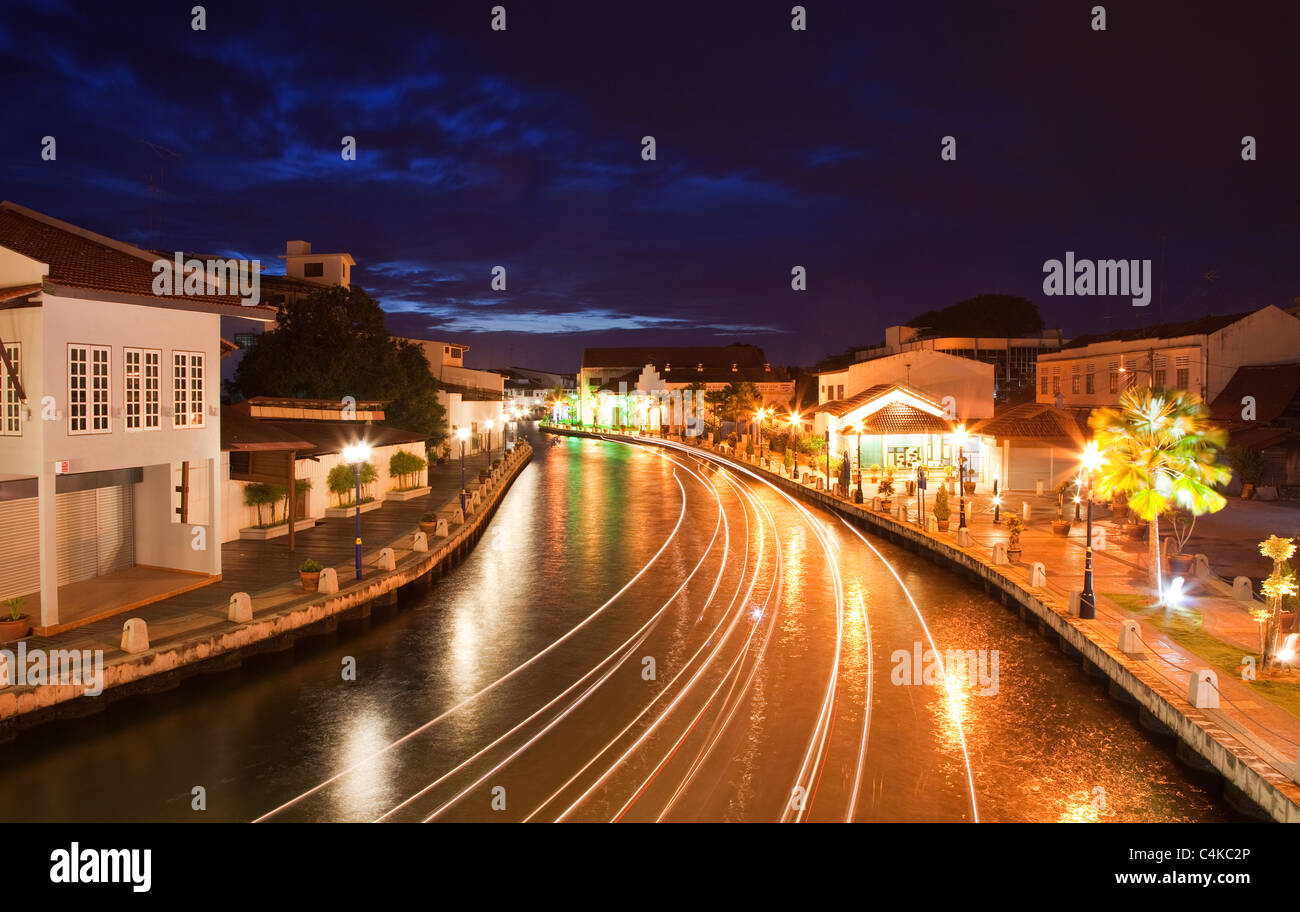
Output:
[0,203,274,316]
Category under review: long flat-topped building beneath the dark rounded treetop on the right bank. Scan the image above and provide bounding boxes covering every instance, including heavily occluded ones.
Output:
[854,326,1062,403]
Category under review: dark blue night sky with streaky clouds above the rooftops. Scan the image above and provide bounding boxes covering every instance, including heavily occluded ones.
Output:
[0,0,1300,370]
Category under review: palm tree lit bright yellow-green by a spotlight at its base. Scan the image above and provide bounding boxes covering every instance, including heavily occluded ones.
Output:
[1088,387,1232,598]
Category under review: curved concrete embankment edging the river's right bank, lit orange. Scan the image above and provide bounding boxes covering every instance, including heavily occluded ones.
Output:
[543,427,1300,822]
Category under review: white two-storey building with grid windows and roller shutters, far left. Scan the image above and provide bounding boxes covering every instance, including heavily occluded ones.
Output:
[0,203,274,633]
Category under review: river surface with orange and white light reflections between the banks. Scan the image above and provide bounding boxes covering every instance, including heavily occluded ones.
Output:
[0,438,1226,821]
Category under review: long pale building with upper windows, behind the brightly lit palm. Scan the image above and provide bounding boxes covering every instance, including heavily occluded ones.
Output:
[1036,305,1300,411]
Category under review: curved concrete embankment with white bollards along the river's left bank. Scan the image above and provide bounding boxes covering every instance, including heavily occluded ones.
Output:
[0,443,532,741]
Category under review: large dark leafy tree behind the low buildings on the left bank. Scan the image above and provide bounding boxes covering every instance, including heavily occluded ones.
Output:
[230,286,446,440]
